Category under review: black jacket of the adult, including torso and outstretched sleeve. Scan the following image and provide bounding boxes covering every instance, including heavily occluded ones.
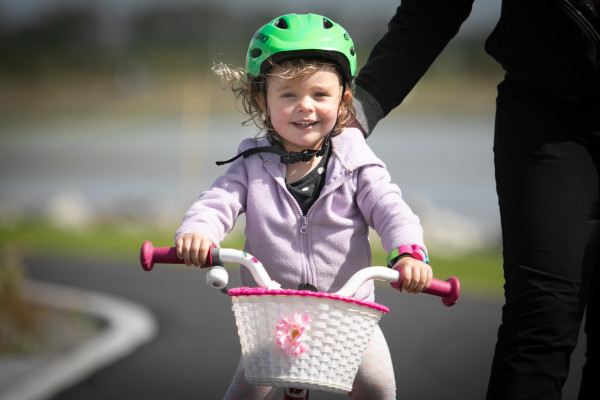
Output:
[356,0,600,116]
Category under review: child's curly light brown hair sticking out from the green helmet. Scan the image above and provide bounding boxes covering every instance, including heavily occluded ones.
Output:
[213,59,356,139]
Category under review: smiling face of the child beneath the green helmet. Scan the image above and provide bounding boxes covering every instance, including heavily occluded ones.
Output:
[267,65,342,151]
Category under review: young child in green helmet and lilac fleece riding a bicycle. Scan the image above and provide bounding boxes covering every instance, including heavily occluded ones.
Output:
[176,14,432,399]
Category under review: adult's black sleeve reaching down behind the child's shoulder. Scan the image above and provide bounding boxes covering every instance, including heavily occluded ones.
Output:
[355,0,473,134]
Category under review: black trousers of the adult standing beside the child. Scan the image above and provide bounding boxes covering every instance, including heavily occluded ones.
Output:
[487,81,600,400]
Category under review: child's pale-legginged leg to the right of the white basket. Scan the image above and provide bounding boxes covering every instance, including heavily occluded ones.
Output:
[350,325,396,400]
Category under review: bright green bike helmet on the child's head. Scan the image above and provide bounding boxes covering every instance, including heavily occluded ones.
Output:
[246,14,356,83]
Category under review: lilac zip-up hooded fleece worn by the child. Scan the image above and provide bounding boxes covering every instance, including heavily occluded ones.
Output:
[175,128,425,301]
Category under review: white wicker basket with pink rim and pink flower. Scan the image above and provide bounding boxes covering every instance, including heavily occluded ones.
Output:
[229,288,389,393]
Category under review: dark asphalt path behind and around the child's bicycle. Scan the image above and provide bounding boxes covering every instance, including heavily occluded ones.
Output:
[27,254,583,400]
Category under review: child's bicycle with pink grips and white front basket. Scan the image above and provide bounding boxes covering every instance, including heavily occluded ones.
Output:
[140,242,460,400]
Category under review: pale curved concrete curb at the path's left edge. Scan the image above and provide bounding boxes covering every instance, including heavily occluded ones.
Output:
[0,282,158,400]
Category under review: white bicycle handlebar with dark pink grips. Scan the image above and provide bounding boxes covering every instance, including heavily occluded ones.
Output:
[140,242,460,307]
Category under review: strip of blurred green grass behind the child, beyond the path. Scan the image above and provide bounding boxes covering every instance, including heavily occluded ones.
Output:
[0,222,503,299]
